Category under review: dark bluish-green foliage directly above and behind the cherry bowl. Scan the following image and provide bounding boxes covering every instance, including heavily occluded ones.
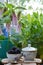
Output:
[10,33,22,49]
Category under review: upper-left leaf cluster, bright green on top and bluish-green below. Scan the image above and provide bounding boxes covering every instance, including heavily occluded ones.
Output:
[0,3,25,24]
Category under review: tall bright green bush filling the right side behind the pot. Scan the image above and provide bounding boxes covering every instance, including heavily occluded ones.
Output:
[19,12,43,54]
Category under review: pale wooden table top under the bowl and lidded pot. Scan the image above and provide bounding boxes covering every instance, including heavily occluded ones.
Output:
[2,57,42,65]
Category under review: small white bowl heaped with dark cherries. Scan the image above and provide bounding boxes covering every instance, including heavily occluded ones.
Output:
[7,47,22,60]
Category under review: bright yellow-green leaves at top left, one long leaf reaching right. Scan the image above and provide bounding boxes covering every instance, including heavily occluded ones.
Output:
[3,3,25,16]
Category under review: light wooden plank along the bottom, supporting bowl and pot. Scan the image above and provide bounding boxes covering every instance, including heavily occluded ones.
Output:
[2,58,42,64]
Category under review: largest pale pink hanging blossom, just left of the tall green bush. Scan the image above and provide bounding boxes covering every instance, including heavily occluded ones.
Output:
[12,12,20,33]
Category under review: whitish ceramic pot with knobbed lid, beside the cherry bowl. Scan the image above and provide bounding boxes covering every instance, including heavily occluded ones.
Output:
[22,44,37,60]
